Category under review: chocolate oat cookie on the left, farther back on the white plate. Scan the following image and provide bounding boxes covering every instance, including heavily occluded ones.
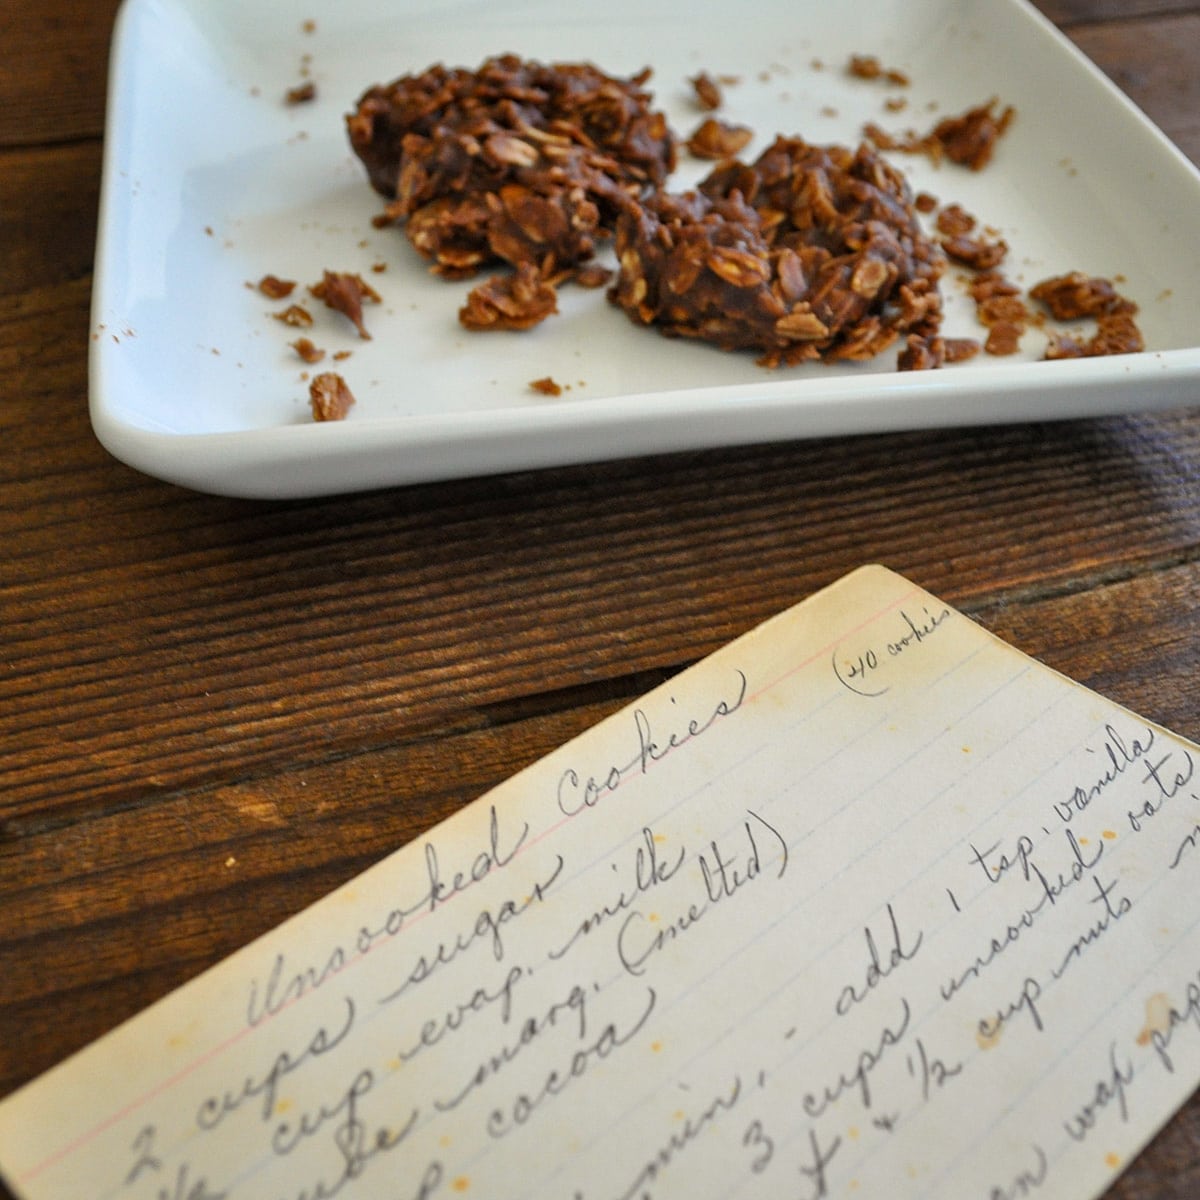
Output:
[347,54,676,278]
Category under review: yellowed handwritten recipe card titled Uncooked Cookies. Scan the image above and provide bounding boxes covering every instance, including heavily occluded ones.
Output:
[0,566,1200,1200]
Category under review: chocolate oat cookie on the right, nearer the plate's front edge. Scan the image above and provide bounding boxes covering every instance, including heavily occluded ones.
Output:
[610,137,944,366]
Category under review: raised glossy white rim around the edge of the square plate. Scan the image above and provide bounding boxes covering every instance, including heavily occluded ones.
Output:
[88,0,1200,499]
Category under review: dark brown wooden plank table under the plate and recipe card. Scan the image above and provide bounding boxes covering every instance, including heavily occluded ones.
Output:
[0,0,1200,1200]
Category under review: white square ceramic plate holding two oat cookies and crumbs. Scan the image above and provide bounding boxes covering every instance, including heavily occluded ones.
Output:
[90,0,1200,497]
